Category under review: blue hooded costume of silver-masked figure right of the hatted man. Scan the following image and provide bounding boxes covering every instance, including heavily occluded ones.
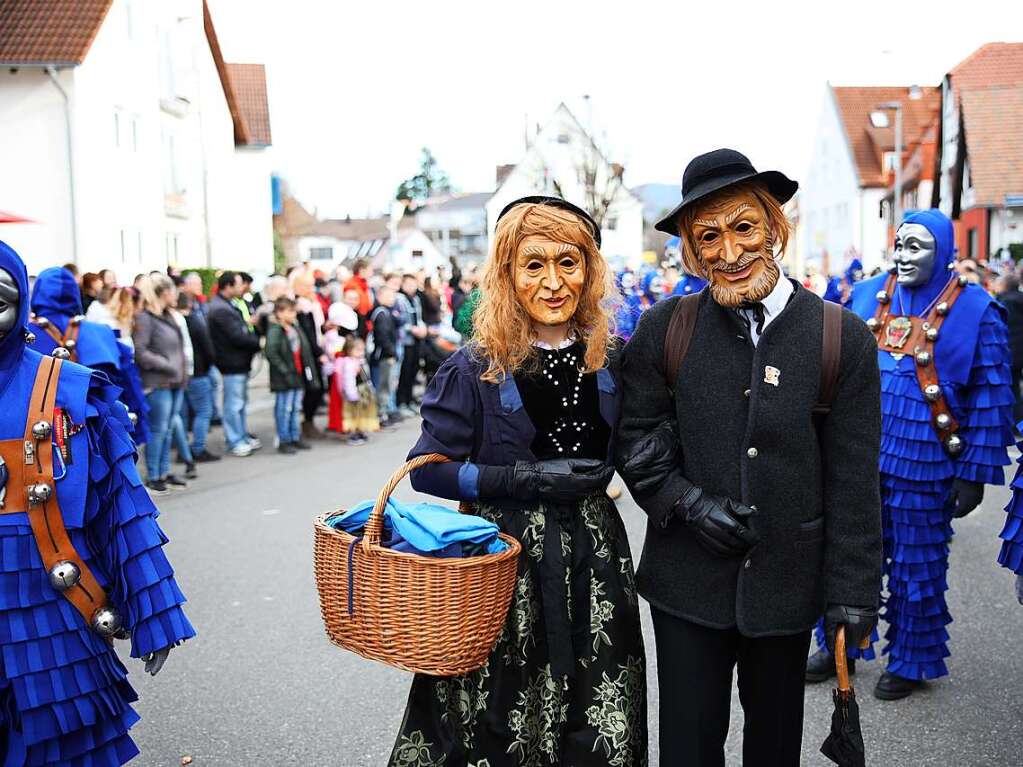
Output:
[817,211,1013,680]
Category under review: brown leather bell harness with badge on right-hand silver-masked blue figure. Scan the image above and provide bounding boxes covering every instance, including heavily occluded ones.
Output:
[866,274,967,456]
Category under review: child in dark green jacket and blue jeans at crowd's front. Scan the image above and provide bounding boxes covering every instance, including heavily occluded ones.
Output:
[264,296,316,455]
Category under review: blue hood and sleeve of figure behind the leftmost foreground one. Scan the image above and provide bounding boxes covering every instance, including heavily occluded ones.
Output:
[29,267,149,445]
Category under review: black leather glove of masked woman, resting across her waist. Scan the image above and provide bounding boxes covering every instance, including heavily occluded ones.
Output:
[480,458,615,503]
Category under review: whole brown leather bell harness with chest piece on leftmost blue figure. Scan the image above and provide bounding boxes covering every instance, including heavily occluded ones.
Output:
[0,357,121,637]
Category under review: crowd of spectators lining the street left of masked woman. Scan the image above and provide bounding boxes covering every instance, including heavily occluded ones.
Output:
[50,256,478,495]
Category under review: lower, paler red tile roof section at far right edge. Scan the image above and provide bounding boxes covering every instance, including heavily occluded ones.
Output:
[962,85,1023,207]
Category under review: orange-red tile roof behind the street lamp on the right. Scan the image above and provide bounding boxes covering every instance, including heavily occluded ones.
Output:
[832,87,941,187]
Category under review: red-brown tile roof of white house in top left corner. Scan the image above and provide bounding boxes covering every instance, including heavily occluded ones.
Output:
[0,0,113,66]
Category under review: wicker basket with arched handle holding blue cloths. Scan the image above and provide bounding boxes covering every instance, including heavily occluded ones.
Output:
[315,454,522,676]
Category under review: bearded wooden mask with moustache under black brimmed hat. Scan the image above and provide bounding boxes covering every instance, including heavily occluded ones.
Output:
[692,191,781,308]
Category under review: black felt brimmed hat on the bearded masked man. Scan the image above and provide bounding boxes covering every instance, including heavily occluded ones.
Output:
[655,149,799,235]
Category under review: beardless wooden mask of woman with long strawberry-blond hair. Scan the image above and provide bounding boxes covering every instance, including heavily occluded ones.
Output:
[513,235,586,325]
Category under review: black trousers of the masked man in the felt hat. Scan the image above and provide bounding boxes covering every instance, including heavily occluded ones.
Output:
[651,607,810,767]
